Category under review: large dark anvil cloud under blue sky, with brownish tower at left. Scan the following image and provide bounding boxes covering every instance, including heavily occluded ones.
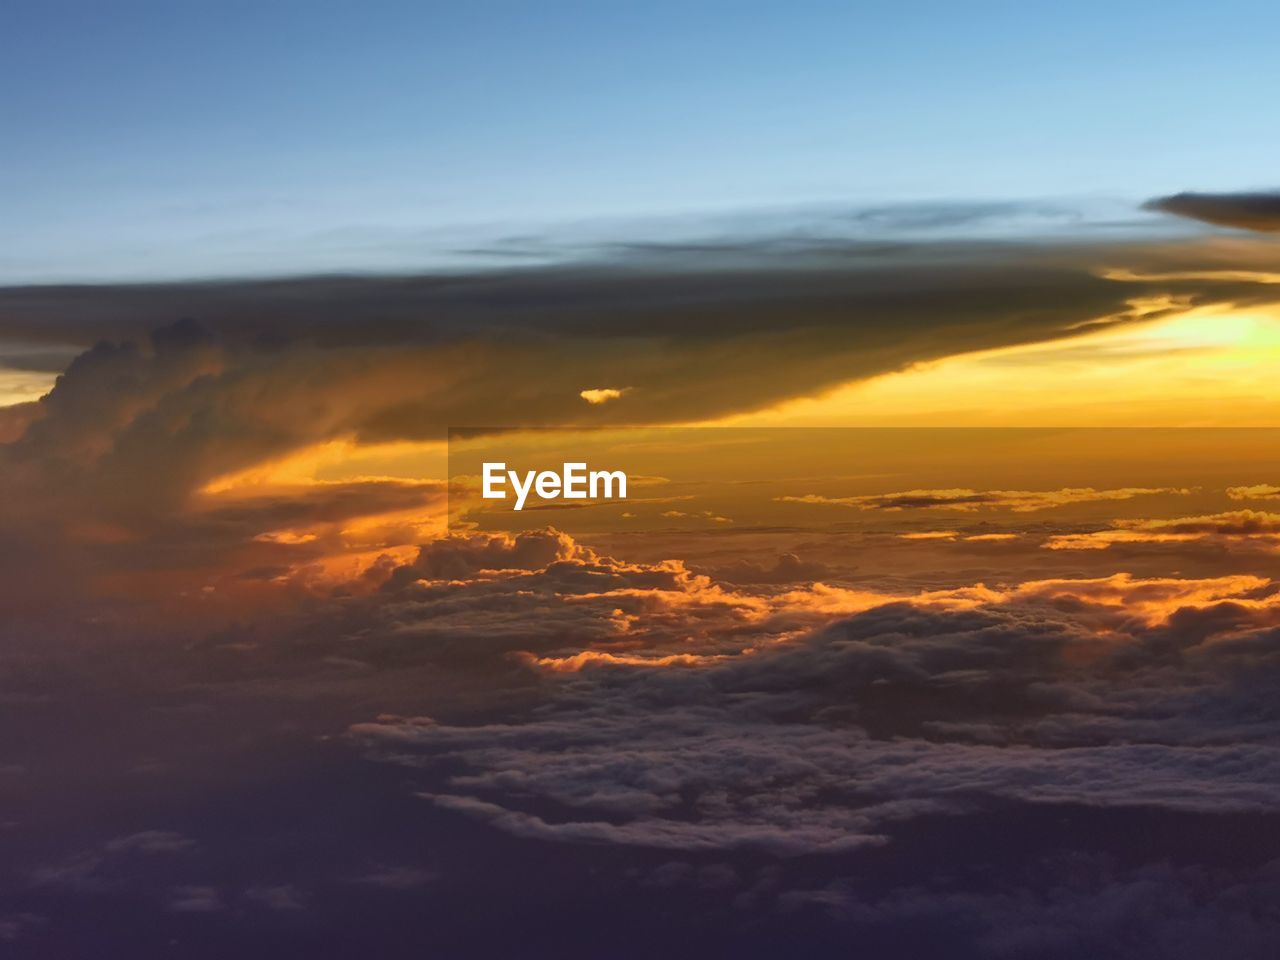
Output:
[0,221,1275,616]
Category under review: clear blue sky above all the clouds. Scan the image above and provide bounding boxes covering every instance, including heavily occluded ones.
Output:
[0,0,1280,283]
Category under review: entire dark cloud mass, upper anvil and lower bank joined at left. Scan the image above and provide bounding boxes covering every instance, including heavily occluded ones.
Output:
[0,224,1280,960]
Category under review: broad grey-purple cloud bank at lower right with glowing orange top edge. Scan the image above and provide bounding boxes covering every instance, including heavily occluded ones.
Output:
[352,555,1280,856]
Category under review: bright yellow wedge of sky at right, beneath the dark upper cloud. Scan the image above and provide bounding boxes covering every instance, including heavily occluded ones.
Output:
[721,302,1280,426]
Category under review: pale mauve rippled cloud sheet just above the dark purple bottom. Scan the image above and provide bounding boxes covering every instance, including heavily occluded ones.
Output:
[353,691,1280,854]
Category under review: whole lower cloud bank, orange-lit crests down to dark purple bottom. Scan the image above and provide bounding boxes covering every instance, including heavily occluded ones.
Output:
[6,531,1280,957]
